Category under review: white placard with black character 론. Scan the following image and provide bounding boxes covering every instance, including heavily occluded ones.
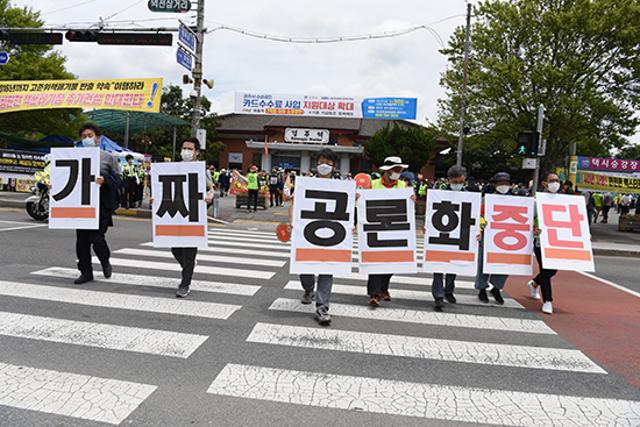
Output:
[358,188,418,274]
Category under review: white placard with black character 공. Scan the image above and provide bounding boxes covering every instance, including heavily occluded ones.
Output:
[291,177,356,274]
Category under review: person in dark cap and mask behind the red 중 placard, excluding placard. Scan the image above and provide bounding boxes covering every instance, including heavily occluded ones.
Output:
[475,172,513,305]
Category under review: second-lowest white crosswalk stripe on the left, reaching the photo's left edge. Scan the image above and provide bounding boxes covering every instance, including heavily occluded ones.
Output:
[0,312,208,359]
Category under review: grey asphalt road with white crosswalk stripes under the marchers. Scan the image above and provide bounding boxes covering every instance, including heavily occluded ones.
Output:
[0,209,640,427]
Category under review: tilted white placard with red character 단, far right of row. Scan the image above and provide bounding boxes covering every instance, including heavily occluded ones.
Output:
[536,193,595,271]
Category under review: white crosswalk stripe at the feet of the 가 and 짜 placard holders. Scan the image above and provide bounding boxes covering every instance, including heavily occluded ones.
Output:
[31,267,260,296]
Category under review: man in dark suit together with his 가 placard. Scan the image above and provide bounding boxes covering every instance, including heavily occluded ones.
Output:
[49,124,121,285]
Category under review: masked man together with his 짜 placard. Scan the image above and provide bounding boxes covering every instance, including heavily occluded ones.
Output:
[151,138,213,298]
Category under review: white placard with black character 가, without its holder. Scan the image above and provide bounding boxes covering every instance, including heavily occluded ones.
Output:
[49,148,100,230]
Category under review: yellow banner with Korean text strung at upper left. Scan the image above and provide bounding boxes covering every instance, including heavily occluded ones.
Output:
[0,78,162,113]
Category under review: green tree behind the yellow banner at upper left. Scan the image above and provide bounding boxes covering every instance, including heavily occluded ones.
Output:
[0,0,83,137]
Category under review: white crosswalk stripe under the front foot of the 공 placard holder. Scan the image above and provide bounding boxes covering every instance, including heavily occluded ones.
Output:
[269,298,555,334]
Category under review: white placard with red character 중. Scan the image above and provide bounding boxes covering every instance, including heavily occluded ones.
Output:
[482,194,535,276]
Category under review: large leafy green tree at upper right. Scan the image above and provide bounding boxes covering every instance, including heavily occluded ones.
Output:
[439,0,640,174]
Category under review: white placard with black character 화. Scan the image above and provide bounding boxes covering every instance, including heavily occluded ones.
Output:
[423,190,481,276]
